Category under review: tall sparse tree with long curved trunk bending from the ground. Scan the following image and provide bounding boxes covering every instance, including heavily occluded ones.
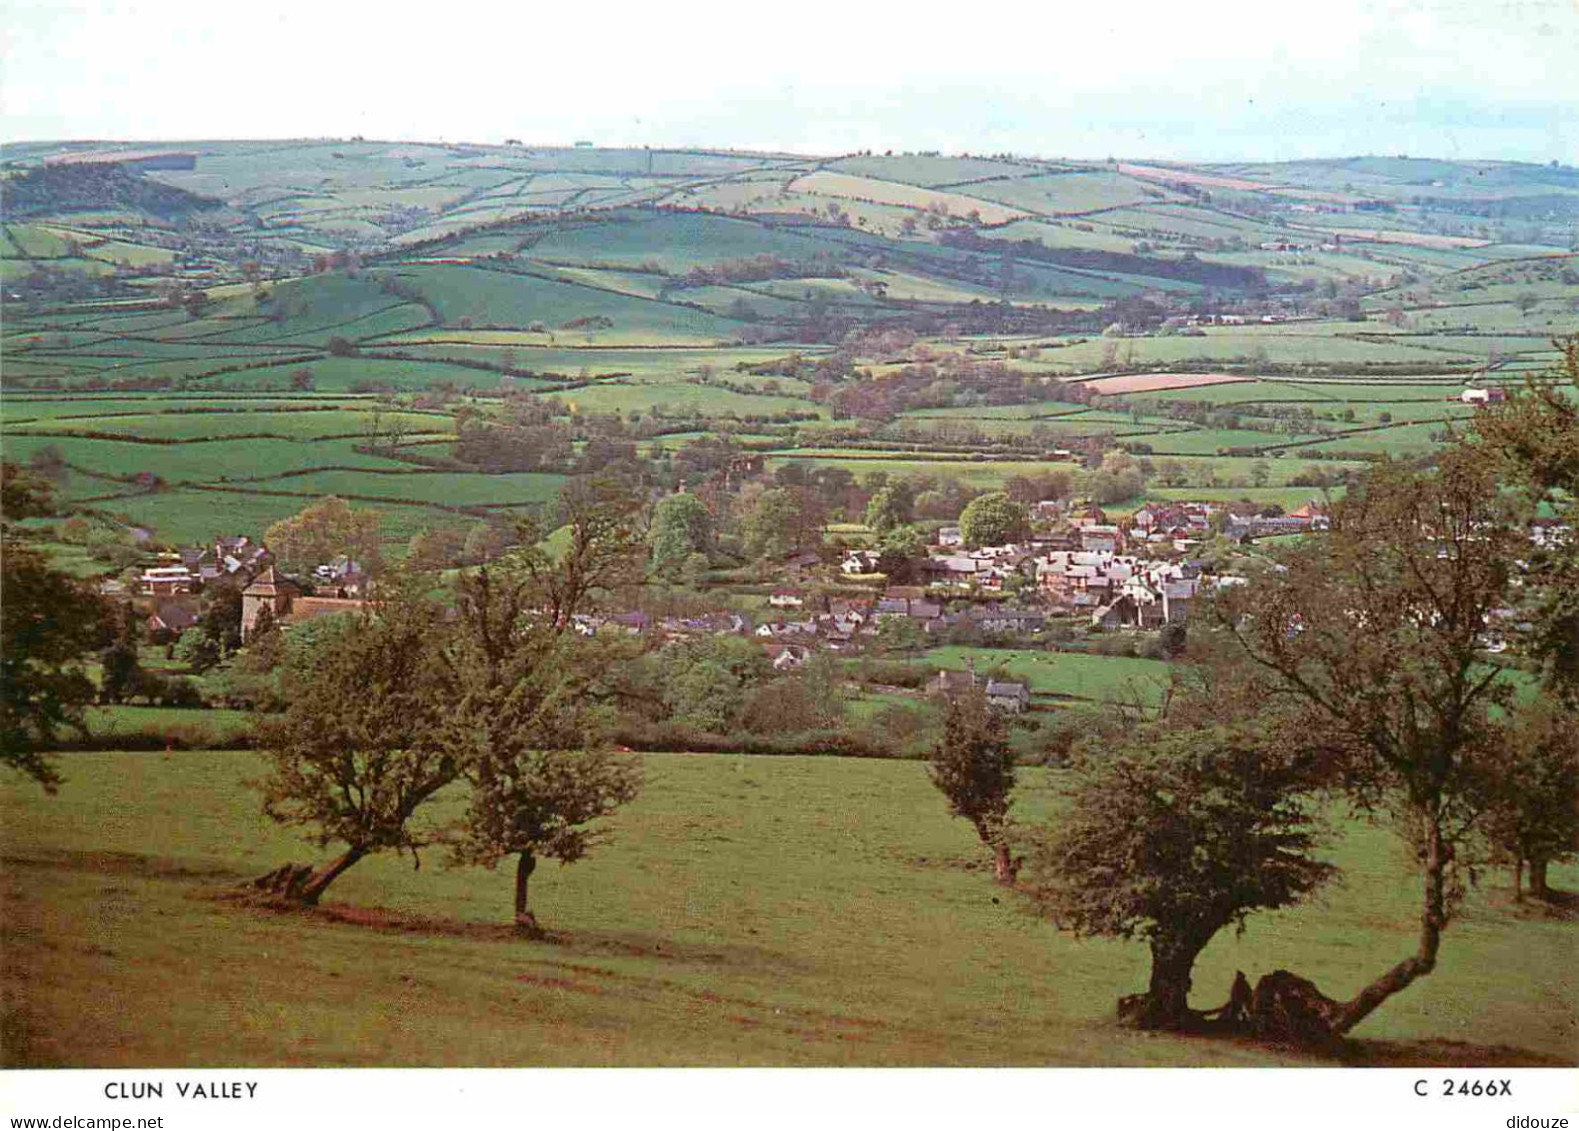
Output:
[1216,452,1528,1036]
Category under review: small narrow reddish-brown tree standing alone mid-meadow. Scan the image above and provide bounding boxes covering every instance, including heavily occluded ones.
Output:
[927,687,1018,883]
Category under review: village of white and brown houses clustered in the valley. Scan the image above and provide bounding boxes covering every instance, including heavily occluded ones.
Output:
[103,480,1328,714]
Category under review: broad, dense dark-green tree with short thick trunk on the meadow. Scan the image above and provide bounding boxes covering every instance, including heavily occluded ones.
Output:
[1030,717,1333,1028]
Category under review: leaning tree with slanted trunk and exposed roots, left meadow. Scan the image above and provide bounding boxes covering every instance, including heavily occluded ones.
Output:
[253,588,459,905]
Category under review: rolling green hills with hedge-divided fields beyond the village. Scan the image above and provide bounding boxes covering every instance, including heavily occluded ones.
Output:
[0,141,1579,552]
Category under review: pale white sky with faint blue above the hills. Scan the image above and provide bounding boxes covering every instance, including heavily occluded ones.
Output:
[0,0,1579,163]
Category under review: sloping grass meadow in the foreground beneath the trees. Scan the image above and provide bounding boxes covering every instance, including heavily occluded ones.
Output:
[0,752,1579,1066]
